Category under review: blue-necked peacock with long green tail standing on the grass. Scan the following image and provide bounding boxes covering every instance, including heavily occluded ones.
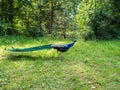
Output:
[5,40,76,52]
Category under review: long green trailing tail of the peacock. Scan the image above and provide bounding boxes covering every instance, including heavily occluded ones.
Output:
[6,44,52,52]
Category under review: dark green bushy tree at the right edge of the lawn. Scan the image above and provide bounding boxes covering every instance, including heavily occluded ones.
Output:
[90,2,120,39]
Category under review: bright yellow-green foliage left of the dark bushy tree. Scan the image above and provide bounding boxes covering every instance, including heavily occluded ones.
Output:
[75,0,94,38]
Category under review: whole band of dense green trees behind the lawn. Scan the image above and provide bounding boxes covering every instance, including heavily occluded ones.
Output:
[0,0,120,39]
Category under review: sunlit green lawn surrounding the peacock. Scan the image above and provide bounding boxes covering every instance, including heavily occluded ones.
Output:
[0,37,120,90]
